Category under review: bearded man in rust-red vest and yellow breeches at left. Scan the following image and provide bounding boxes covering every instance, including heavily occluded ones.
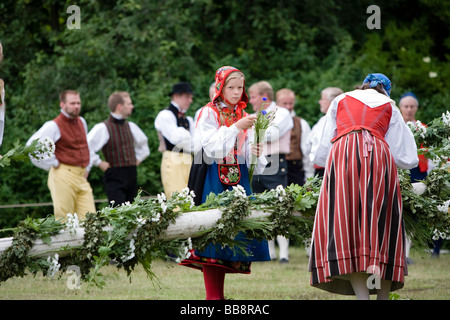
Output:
[27,90,96,220]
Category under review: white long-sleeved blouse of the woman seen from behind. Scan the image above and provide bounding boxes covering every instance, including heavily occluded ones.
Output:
[310,89,419,169]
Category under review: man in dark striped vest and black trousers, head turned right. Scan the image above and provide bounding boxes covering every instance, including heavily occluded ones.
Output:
[88,91,150,206]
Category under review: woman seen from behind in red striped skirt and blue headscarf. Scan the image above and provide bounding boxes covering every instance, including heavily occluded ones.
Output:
[309,73,418,299]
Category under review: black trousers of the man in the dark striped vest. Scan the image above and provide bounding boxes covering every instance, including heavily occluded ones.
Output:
[103,166,138,207]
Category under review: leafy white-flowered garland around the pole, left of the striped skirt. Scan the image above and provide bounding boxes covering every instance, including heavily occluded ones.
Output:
[0,178,321,288]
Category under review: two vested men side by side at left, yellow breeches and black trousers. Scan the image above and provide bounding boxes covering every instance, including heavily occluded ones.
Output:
[27,90,150,220]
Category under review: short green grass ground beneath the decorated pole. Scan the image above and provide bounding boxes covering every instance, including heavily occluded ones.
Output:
[0,247,450,300]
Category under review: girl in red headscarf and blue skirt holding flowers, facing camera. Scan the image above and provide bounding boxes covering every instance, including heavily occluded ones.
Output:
[181,66,270,300]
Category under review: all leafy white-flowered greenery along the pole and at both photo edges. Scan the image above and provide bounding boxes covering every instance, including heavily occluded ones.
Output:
[0,111,450,287]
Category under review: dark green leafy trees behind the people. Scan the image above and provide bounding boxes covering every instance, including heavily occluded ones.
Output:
[0,0,450,226]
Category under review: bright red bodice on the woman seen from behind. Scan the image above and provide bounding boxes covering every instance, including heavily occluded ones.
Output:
[332,96,392,141]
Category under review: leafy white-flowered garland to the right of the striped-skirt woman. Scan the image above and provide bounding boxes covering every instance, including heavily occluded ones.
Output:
[399,111,450,244]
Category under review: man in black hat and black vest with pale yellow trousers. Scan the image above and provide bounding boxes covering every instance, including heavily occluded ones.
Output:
[155,82,194,199]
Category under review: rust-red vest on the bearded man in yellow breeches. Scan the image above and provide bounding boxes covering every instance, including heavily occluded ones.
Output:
[53,113,89,168]
